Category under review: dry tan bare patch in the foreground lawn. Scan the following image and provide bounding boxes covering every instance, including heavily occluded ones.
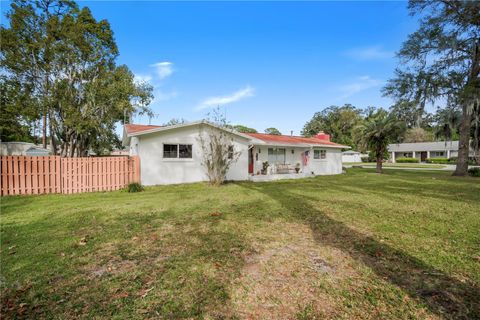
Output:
[231,223,354,319]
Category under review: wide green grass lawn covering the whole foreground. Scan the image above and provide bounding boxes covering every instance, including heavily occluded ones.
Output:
[0,169,480,319]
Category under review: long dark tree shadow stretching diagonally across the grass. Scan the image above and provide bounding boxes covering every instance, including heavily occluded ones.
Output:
[242,184,480,319]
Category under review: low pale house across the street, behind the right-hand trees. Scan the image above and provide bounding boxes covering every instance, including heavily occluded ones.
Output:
[388,141,473,163]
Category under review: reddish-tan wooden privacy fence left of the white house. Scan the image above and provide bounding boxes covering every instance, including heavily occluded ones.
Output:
[0,156,140,196]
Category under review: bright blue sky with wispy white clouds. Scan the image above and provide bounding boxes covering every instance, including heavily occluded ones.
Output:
[2,1,417,134]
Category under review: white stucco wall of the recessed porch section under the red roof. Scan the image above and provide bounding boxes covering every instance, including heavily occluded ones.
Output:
[253,145,342,175]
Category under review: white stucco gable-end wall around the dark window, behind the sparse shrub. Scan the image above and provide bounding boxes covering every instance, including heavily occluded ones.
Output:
[134,125,248,185]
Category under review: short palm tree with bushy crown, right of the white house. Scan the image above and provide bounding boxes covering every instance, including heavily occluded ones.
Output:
[358,109,406,173]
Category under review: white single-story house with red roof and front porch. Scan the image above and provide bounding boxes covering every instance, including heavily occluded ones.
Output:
[123,121,348,185]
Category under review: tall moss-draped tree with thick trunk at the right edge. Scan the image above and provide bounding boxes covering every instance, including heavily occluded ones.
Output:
[384,0,480,176]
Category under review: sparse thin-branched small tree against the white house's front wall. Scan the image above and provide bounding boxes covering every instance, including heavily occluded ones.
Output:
[198,109,241,186]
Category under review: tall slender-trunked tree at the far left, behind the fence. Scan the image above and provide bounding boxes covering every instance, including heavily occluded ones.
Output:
[0,0,76,148]
